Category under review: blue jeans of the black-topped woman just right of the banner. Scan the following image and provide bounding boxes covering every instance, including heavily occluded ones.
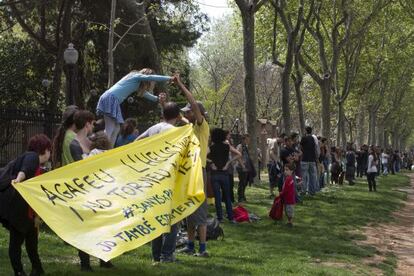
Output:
[211,172,233,220]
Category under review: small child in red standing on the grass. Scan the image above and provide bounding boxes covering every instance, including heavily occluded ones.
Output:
[280,164,296,227]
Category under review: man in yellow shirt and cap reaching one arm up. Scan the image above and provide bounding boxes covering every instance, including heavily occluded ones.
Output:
[174,74,210,257]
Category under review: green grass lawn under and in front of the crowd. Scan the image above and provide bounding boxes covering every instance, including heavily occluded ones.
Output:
[0,175,409,276]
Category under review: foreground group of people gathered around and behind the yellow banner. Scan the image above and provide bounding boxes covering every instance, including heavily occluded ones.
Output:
[0,69,210,276]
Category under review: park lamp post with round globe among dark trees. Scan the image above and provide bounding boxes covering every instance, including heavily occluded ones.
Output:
[63,43,79,105]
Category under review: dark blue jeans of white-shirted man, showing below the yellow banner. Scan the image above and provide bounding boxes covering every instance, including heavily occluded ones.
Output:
[151,224,178,262]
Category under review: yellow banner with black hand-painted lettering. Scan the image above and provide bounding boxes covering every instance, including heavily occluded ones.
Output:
[15,125,205,261]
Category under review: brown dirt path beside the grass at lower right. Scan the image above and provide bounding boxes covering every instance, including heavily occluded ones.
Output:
[360,174,414,275]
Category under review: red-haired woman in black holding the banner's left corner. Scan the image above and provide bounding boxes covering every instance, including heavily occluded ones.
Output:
[0,134,51,276]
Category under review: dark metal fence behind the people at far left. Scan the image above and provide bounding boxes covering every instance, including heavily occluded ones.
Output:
[0,108,61,166]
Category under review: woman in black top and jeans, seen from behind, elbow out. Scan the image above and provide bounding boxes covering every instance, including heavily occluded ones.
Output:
[207,128,241,222]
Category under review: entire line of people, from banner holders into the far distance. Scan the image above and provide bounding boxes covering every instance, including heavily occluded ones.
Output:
[0,69,413,275]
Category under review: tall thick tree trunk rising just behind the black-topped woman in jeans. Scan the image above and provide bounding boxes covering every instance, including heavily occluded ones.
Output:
[241,9,259,177]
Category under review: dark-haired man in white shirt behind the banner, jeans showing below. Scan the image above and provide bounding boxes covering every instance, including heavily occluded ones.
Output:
[136,102,181,263]
